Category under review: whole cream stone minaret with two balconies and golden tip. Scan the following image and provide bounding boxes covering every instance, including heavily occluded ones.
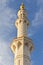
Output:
[11,4,33,65]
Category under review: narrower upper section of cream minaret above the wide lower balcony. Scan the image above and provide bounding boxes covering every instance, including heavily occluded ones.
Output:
[15,4,29,37]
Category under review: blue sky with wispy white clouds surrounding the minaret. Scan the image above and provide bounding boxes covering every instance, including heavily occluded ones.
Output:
[0,0,43,65]
